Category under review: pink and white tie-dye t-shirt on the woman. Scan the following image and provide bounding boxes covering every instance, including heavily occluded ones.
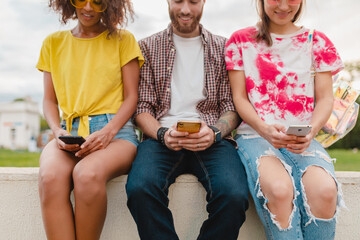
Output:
[225,27,344,134]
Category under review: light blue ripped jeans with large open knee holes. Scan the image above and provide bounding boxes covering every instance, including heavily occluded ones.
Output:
[236,135,345,240]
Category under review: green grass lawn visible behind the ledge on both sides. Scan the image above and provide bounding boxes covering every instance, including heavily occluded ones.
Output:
[0,149,360,171]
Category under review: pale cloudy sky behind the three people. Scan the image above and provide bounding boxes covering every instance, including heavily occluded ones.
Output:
[0,0,360,103]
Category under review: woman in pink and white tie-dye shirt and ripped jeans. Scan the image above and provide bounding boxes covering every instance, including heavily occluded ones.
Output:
[226,0,343,240]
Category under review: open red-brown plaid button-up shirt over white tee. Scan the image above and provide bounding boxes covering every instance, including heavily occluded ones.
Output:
[135,25,235,125]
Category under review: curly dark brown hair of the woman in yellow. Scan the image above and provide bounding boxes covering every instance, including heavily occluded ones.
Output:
[49,0,134,36]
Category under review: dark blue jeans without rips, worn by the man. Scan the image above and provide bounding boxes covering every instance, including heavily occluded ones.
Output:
[126,139,248,240]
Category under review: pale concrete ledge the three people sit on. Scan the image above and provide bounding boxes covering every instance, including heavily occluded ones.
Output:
[0,168,360,240]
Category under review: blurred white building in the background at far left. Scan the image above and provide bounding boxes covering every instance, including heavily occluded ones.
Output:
[0,99,40,149]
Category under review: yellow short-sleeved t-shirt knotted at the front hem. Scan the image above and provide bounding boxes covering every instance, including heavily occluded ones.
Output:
[36,30,144,137]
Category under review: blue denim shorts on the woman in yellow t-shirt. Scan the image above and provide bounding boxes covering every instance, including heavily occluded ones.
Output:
[61,113,139,147]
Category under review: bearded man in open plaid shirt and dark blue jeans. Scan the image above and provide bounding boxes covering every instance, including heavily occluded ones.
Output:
[126,0,248,240]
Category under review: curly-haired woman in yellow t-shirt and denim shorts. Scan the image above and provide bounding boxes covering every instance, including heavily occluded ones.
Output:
[36,0,144,240]
